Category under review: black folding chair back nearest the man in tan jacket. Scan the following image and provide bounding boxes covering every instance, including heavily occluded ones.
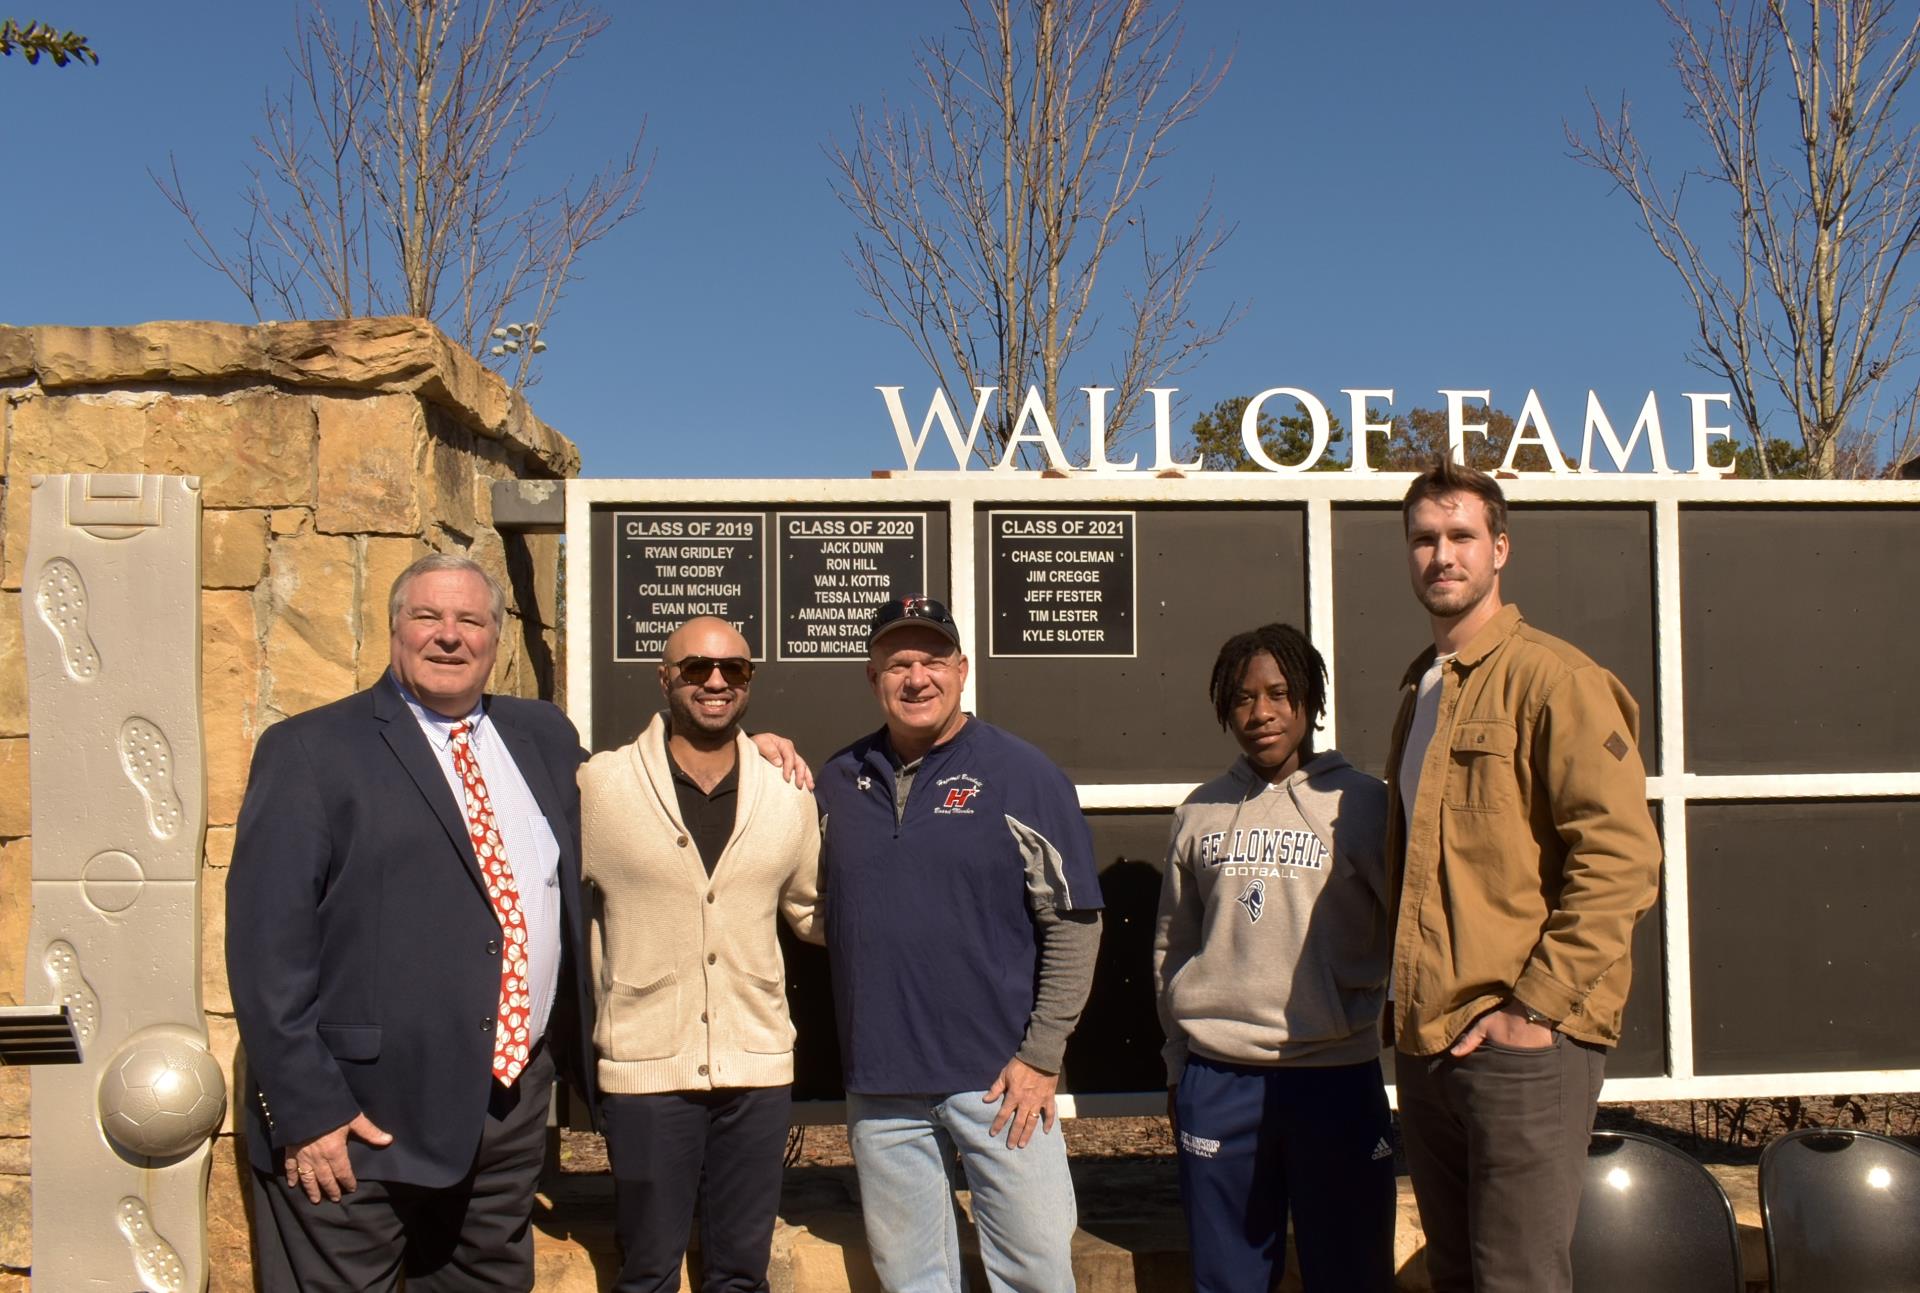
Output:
[1572,1132,1745,1293]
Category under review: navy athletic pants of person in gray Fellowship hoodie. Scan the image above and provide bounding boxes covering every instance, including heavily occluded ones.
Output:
[1175,1055,1396,1293]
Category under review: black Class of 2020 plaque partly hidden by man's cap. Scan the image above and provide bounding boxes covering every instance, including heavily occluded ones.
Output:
[776,511,929,661]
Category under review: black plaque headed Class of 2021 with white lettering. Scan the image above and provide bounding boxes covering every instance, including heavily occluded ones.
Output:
[987,511,1139,657]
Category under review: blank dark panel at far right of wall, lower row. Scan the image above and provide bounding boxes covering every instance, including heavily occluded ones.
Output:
[1688,799,1920,1074]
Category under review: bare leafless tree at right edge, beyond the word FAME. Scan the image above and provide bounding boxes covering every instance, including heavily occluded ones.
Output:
[1567,0,1920,476]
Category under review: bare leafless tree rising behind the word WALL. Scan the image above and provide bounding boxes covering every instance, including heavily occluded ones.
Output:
[828,0,1240,461]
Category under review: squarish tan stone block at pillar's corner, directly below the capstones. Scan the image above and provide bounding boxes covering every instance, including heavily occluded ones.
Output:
[315,396,426,534]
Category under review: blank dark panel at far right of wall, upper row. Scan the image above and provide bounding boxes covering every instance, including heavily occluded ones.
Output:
[1680,507,1920,774]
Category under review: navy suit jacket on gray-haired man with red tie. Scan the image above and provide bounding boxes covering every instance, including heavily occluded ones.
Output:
[227,674,593,1187]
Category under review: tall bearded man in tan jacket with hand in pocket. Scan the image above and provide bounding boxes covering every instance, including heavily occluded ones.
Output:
[1386,461,1661,1293]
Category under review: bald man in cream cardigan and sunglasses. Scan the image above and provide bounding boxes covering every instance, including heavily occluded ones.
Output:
[580,617,824,1293]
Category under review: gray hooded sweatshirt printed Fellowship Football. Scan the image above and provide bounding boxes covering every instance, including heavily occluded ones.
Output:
[1154,751,1392,1086]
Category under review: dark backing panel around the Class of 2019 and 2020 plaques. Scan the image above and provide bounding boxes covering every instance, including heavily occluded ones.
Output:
[589,503,948,767]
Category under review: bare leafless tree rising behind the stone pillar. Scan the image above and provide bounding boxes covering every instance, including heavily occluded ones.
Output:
[154,0,649,384]
